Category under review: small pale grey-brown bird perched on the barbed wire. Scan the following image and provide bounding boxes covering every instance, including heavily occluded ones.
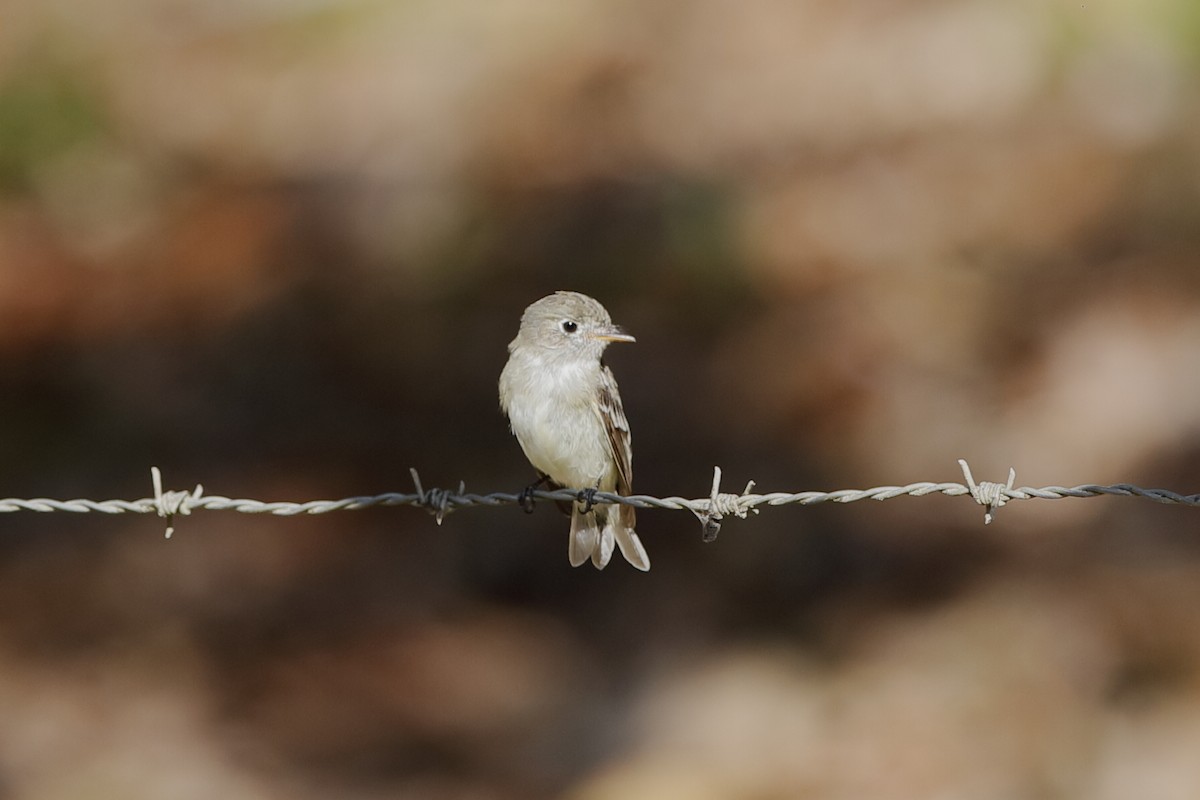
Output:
[500,291,650,571]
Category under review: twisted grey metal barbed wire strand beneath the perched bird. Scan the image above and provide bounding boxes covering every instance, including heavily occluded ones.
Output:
[0,458,1200,541]
